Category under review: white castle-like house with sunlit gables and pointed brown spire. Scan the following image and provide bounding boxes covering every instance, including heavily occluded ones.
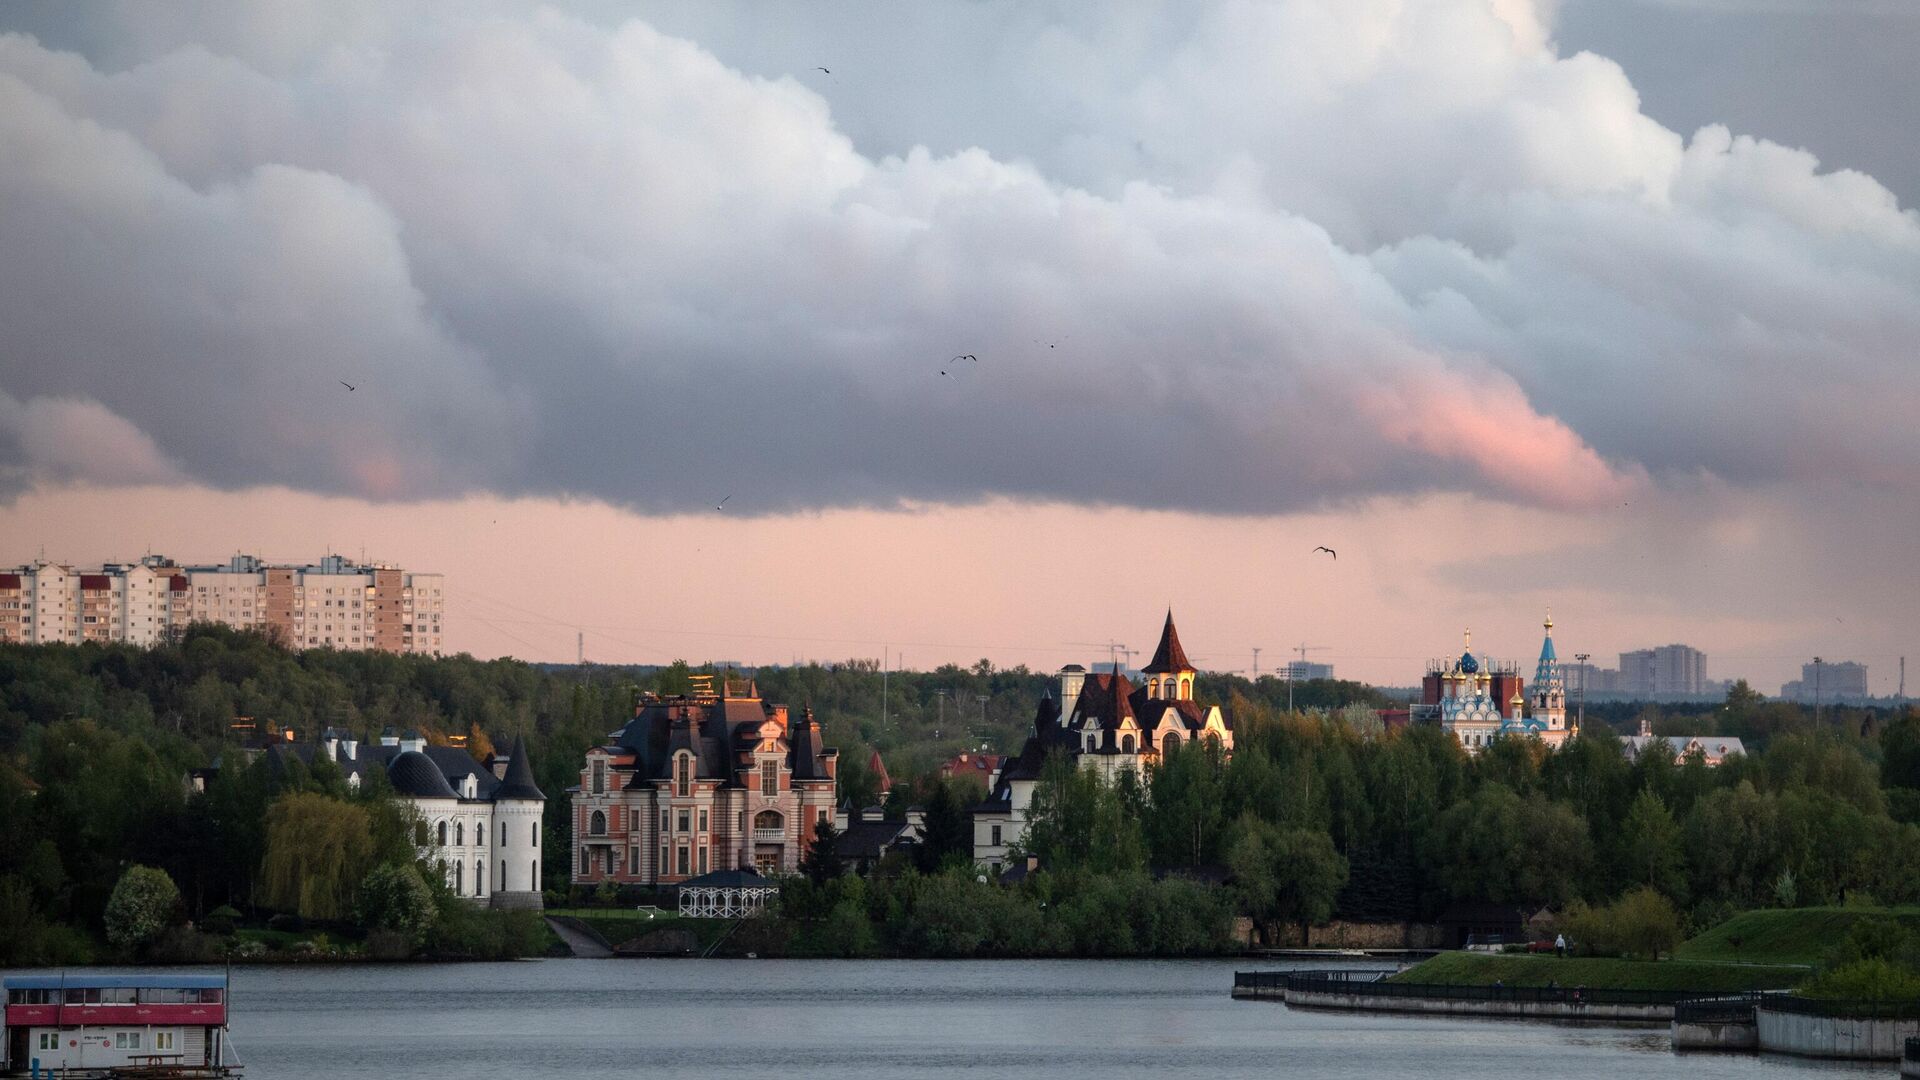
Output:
[972,611,1233,872]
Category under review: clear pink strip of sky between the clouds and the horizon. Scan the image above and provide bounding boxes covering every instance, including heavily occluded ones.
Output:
[0,478,1908,692]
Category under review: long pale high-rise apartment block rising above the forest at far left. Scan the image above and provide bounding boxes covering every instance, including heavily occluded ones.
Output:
[0,555,445,653]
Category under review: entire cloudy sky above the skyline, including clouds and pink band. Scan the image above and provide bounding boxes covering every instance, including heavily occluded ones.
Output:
[0,0,1920,692]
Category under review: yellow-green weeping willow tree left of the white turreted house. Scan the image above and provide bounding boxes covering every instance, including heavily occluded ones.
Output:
[261,792,374,919]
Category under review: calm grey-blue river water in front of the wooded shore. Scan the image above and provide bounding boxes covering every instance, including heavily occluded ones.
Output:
[127,961,1866,1080]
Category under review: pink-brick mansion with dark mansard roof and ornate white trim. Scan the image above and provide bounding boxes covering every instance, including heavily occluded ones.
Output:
[572,680,839,886]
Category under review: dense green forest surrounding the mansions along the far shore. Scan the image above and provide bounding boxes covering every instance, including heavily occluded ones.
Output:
[0,626,1920,961]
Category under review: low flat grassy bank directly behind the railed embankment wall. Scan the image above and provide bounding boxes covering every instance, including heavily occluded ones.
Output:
[1392,953,1807,992]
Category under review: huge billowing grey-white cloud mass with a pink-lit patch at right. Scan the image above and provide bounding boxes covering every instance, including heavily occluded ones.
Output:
[0,0,1920,511]
